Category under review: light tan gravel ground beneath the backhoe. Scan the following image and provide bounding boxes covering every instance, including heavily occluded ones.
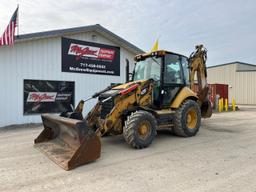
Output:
[0,106,256,192]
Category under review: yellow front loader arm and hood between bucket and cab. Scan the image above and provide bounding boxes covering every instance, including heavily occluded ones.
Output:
[90,80,153,135]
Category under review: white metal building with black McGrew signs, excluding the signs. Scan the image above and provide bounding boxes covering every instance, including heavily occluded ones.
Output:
[0,24,143,127]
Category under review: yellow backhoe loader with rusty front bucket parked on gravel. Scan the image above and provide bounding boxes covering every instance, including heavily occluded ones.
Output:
[34,45,212,170]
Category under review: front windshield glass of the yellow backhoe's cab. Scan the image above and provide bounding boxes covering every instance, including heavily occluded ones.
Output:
[133,57,162,81]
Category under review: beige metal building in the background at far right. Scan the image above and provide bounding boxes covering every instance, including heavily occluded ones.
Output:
[208,61,256,105]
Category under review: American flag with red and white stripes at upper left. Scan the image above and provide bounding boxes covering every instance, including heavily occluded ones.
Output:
[0,7,19,46]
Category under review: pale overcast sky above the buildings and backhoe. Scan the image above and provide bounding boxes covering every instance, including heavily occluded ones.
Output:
[0,0,256,66]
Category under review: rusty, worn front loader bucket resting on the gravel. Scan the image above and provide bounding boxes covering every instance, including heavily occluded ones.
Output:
[34,114,101,170]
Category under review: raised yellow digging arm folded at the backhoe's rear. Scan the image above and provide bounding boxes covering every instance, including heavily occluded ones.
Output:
[189,45,212,117]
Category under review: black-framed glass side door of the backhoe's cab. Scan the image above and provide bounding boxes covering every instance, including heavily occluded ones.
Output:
[160,53,186,108]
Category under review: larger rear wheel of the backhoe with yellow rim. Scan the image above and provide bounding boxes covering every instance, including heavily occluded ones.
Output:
[173,100,201,137]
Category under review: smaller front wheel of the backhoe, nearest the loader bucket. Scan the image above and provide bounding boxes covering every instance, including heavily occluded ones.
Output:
[123,111,157,149]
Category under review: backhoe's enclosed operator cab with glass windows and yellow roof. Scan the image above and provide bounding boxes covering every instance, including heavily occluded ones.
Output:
[132,50,190,108]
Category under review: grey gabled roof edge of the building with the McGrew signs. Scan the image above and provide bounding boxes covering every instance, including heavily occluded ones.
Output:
[16,24,144,54]
